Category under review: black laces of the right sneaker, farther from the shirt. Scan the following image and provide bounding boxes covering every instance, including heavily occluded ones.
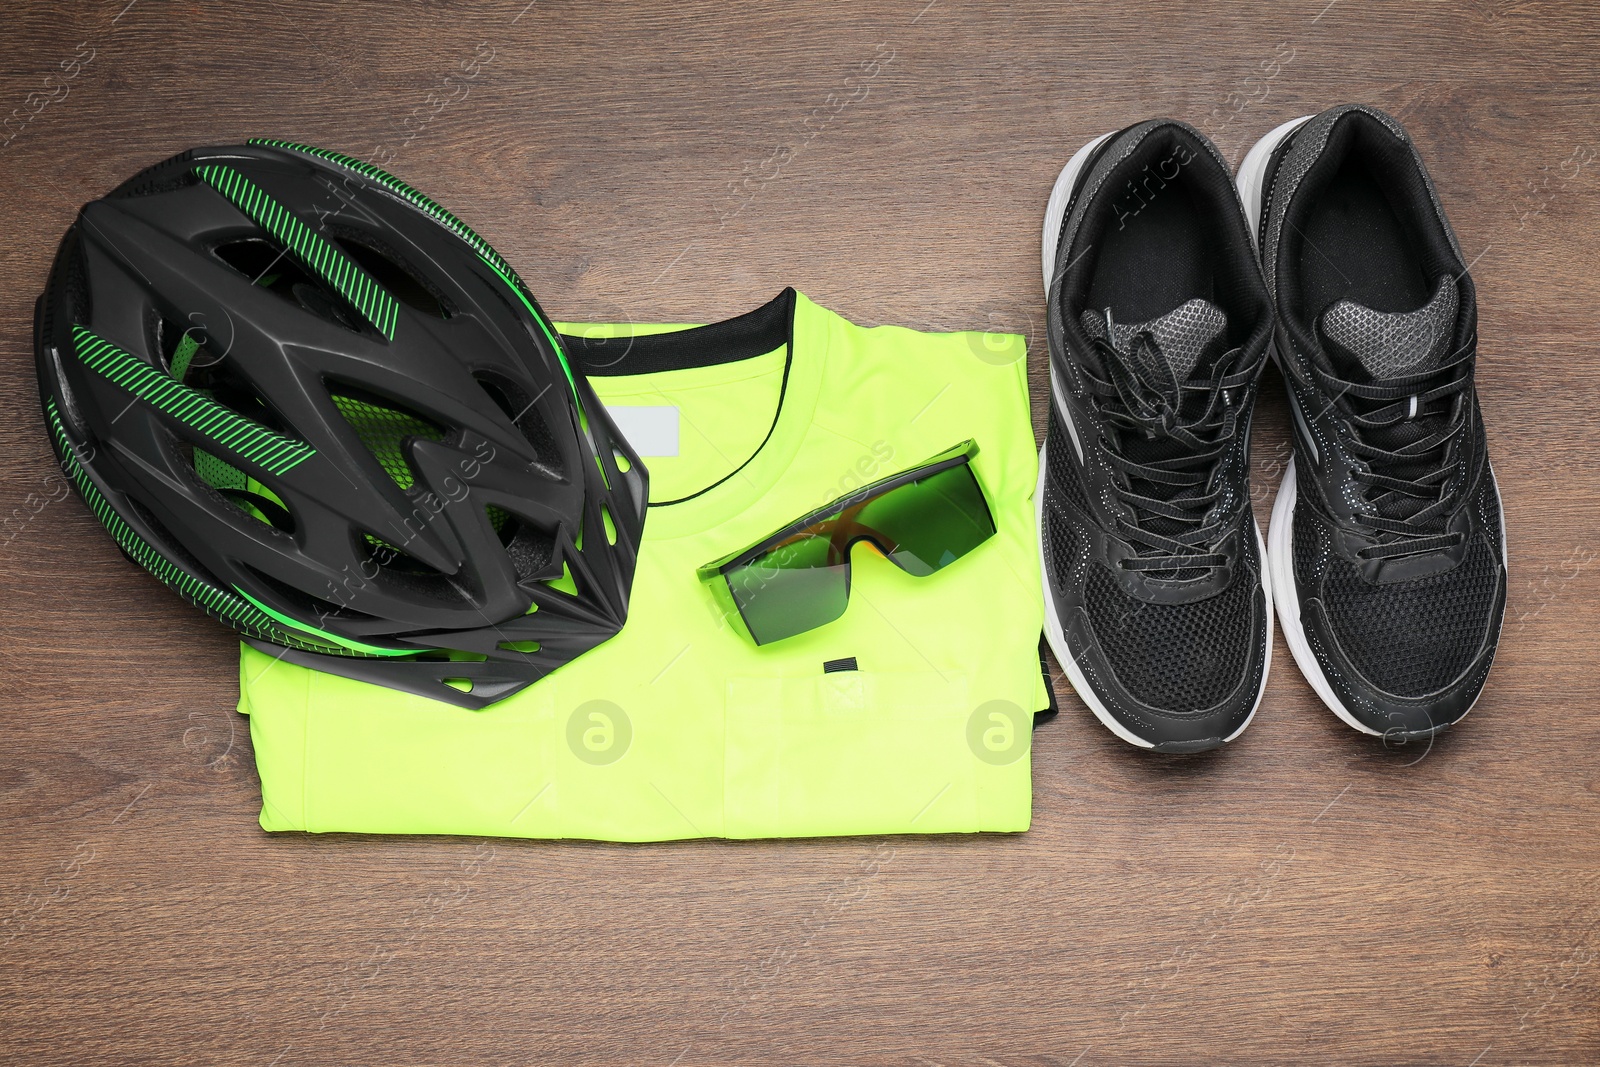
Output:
[1312,339,1477,560]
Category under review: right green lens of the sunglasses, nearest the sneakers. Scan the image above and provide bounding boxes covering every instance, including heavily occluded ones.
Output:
[854,464,995,577]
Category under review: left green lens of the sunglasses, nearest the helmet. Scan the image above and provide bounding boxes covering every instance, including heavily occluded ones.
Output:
[723,522,850,645]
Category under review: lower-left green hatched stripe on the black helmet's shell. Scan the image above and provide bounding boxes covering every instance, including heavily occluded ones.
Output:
[72,323,317,475]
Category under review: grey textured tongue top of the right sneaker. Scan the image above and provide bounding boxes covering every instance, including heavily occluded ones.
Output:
[1322,274,1459,379]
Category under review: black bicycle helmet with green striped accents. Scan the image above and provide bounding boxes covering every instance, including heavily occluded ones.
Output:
[34,141,646,707]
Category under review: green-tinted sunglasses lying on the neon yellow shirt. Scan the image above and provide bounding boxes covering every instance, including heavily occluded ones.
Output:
[698,442,995,645]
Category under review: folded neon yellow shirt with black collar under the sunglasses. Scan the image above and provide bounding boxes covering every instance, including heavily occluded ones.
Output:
[238,290,1048,841]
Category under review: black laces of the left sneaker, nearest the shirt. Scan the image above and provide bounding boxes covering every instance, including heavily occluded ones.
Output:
[1085,309,1264,573]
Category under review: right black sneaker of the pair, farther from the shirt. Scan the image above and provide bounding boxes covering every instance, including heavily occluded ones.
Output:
[1238,106,1506,739]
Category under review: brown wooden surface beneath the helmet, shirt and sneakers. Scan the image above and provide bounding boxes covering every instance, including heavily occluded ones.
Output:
[0,0,1600,1067]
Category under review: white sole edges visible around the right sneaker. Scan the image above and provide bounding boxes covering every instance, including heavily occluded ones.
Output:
[1234,115,1510,737]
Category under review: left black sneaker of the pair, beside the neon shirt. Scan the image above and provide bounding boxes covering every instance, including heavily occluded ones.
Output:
[1035,122,1272,752]
